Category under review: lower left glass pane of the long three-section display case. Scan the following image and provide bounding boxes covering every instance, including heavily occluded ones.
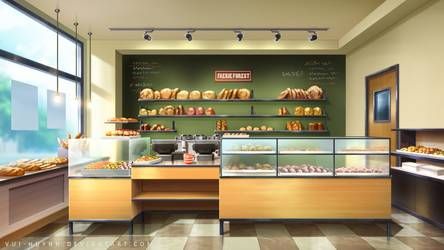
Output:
[221,155,276,176]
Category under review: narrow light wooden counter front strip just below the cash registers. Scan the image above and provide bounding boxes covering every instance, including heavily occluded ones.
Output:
[131,167,219,180]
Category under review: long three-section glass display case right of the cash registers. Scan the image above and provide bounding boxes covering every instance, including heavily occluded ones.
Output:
[221,137,390,177]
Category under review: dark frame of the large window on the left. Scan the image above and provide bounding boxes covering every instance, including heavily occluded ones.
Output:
[0,0,85,133]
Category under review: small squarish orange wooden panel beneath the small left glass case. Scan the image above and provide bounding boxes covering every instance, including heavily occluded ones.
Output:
[69,178,138,220]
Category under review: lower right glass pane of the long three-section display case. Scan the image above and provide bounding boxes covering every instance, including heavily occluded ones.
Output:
[335,155,390,176]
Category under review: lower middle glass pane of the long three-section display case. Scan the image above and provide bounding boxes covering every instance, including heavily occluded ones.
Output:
[278,155,333,176]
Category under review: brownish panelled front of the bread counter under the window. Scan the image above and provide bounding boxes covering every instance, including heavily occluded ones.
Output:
[0,165,68,238]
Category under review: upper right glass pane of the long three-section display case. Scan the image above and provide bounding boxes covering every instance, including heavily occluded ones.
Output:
[335,138,390,154]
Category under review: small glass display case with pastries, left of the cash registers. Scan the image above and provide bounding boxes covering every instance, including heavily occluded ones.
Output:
[68,138,150,178]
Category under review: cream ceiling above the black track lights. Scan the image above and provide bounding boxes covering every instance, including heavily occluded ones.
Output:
[25,0,384,40]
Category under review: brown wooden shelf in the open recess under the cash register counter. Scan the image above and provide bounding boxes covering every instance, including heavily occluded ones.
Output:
[133,191,219,201]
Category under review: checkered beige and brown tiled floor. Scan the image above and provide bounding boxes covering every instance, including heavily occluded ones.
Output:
[2,209,444,250]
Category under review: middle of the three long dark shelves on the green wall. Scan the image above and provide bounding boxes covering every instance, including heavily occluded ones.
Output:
[138,115,327,119]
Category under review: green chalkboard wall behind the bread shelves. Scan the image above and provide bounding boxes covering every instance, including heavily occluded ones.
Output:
[122,55,345,138]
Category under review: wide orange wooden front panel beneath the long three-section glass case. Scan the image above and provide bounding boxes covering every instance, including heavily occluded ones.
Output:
[219,178,391,219]
